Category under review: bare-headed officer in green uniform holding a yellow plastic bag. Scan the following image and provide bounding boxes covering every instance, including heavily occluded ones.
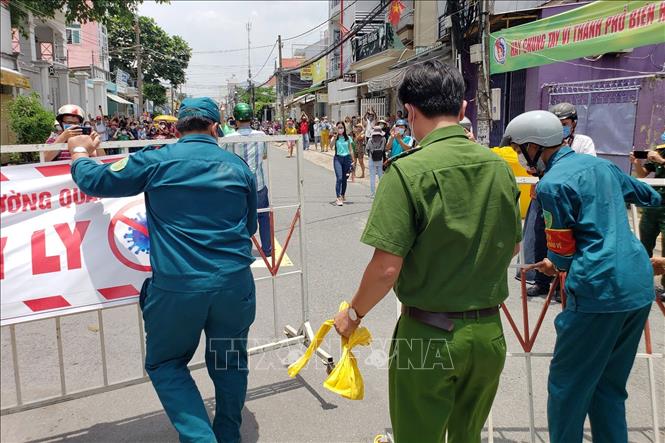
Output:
[335,61,521,443]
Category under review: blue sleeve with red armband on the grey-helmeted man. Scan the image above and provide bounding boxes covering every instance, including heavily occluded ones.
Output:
[538,183,580,271]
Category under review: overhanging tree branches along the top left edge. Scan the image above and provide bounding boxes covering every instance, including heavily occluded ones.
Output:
[8,0,167,33]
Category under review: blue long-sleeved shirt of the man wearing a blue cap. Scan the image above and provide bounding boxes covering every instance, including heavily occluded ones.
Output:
[72,134,257,290]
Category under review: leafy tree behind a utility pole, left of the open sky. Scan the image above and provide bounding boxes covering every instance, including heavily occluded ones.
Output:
[107,16,192,86]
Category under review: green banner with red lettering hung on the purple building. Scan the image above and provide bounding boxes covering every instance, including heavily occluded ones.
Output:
[490,0,665,74]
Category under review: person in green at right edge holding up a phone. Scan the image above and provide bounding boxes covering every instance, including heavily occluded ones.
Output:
[630,132,665,290]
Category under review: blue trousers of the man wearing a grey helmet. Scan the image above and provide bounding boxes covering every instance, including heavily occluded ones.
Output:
[547,305,651,443]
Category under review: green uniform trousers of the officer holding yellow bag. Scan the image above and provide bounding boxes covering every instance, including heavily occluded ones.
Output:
[389,314,506,443]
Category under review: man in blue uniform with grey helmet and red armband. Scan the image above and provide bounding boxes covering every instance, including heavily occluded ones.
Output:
[501,111,661,443]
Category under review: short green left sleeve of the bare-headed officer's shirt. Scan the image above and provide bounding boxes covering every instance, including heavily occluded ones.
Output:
[360,165,417,257]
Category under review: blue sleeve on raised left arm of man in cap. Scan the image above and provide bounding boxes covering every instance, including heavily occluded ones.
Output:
[72,151,158,197]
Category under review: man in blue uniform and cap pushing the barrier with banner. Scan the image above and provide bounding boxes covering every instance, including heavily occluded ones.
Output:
[68,98,257,442]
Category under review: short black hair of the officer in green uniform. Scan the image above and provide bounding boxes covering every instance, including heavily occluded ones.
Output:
[397,60,464,117]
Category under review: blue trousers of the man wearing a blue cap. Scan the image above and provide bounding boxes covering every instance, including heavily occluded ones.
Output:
[140,269,256,443]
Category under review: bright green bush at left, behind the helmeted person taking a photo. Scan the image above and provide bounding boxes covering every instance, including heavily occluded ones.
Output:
[7,92,55,163]
